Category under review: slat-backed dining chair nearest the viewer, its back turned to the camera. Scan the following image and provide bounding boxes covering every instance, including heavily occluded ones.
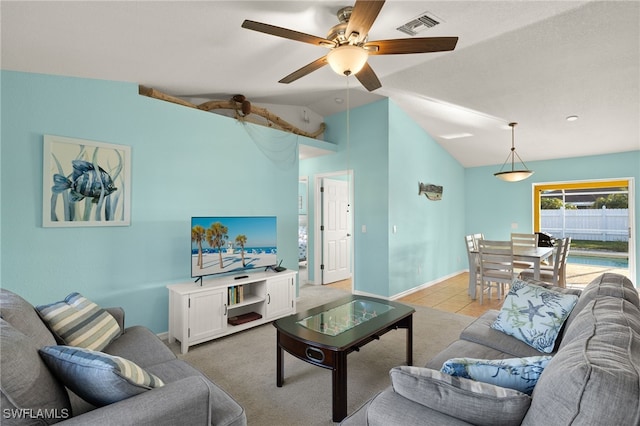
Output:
[478,239,514,305]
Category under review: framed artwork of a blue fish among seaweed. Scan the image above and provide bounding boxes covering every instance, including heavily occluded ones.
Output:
[42,135,131,227]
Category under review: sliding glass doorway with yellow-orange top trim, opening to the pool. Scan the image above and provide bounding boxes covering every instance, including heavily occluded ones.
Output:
[533,178,636,285]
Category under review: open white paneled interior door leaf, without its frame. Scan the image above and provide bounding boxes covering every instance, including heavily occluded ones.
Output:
[321,178,351,284]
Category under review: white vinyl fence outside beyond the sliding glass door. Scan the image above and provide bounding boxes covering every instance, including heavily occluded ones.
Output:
[540,209,629,241]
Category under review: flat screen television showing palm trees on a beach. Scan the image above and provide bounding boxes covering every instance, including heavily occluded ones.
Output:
[191,216,278,278]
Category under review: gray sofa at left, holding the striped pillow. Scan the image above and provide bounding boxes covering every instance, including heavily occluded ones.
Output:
[0,289,247,426]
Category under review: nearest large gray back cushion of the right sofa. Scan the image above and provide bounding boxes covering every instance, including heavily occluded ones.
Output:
[523,296,640,425]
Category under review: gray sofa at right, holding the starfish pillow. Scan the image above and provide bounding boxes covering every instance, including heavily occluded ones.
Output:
[341,273,640,426]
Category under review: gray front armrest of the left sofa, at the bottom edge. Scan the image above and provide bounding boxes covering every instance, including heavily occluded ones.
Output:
[59,376,211,426]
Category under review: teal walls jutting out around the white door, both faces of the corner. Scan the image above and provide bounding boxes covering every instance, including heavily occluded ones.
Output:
[300,99,466,297]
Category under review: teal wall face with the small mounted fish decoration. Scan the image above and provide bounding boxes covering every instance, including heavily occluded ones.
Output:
[387,102,467,295]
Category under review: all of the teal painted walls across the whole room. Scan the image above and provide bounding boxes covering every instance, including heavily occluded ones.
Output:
[0,71,640,332]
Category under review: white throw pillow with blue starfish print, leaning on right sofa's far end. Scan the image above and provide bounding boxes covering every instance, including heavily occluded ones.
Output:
[491,279,578,353]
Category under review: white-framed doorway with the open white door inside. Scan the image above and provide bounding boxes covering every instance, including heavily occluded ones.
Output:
[313,171,354,288]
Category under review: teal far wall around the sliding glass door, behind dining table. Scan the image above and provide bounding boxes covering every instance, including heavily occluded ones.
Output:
[465,153,640,285]
